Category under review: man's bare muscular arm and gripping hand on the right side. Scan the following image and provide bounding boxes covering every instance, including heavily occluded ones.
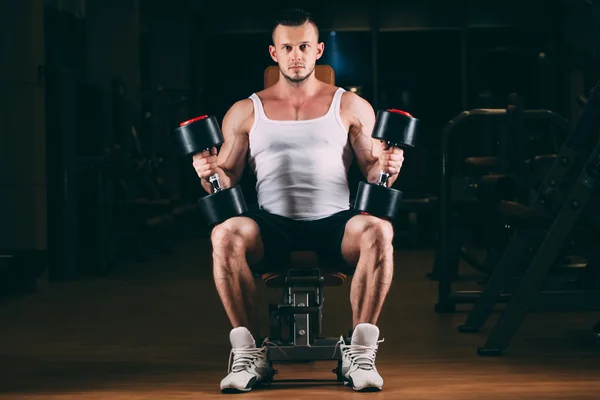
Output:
[344,92,404,187]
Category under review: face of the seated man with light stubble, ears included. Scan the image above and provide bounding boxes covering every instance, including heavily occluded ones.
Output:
[269,22,325,83]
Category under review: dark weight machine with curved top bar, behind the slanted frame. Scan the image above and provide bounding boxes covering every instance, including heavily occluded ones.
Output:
[430,95,567,313]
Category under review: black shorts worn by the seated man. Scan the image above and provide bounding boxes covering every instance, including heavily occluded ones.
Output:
[244,206,360,275]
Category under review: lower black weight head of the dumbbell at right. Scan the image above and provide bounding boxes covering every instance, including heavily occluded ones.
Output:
[354,182,402,219]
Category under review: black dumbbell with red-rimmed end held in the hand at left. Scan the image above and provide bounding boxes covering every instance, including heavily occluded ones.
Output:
[173,115,248,226]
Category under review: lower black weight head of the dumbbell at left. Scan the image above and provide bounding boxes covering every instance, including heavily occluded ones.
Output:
[198,186,248,226]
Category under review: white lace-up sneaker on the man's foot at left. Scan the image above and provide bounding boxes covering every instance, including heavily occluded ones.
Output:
[221,327,273,393]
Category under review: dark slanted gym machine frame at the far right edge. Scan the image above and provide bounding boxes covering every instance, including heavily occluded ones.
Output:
[459,82,600,356]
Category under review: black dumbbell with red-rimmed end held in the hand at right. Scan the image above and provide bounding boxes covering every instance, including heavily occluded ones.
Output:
[354,108,419,219]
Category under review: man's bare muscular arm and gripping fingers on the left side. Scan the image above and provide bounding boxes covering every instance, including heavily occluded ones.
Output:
[201,99,254,193]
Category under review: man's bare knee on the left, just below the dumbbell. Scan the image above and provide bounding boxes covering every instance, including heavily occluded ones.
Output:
[210,218,258,254]
